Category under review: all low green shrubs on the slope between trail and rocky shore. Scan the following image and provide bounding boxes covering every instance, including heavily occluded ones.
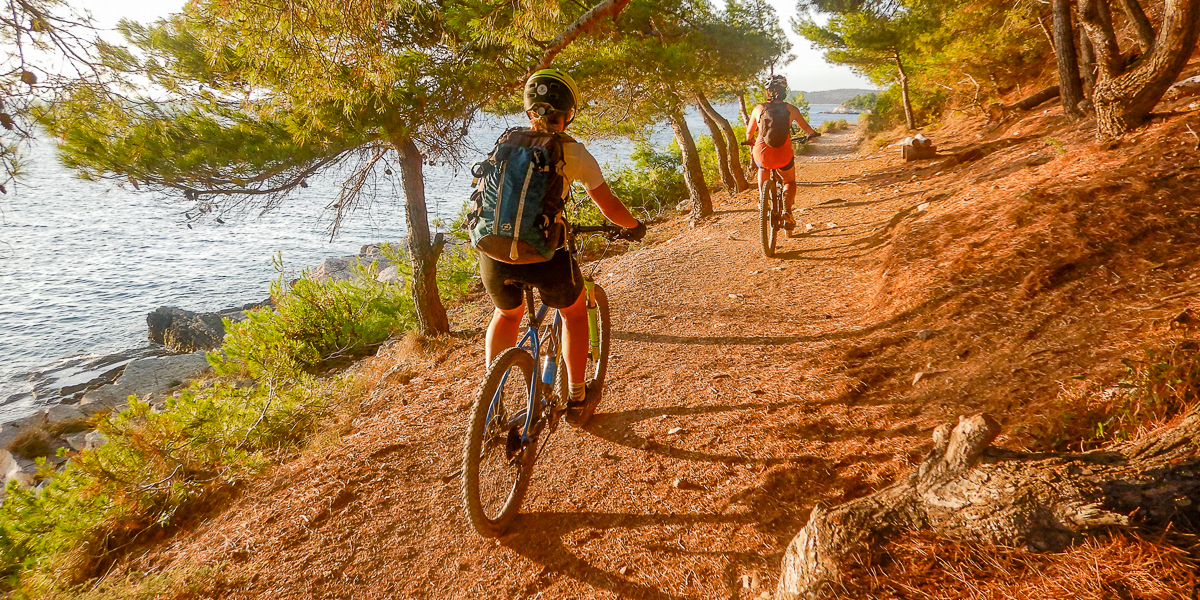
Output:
[0,246,487,598]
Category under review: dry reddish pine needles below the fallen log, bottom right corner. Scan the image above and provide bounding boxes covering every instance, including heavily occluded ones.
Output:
[836,534,1196,600]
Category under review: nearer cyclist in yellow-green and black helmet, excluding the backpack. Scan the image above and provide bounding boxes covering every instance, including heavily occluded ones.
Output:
[479,68,646,404]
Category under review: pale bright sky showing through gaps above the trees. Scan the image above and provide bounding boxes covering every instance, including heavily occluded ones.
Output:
[77,0,875,91]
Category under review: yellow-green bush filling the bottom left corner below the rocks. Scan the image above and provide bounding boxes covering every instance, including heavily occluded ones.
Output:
[0,373,349,598]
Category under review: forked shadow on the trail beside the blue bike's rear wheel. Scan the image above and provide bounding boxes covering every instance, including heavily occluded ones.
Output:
[500,512,755,600]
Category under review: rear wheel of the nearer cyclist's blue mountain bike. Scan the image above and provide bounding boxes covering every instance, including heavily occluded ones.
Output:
[462,348,538,538]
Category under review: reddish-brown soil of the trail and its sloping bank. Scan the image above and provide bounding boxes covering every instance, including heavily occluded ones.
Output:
[121,96,1200,600]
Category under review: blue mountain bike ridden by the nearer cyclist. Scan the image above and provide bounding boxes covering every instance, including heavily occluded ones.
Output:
[462,226,623,538]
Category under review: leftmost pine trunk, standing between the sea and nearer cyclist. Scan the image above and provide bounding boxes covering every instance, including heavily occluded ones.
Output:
[390,133,450,335]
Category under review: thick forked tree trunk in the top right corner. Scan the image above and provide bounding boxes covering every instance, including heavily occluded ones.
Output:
[1080,0,1200,138]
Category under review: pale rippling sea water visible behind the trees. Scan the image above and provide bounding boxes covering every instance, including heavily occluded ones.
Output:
[0,104,856,422]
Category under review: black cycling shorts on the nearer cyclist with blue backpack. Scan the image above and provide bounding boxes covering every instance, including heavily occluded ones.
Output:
[479,248,583,311]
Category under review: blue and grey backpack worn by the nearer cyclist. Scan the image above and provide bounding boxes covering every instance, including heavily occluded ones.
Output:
[466,127,574,264]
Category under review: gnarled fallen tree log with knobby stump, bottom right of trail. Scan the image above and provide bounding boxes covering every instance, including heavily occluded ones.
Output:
[775,410,1200,600]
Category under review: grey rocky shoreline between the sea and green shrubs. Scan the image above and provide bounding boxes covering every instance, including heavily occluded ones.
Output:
[0,244,403,498]
